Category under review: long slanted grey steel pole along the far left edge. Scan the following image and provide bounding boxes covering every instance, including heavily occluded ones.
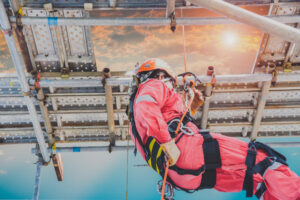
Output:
[0,0,50,162]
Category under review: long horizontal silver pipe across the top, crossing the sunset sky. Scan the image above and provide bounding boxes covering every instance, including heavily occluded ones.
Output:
[10,15,300,26]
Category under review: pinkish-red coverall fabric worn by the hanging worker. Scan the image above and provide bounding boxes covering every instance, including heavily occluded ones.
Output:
[132,79,300,200]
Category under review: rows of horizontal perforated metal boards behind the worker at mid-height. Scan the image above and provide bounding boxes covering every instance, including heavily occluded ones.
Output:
[0,74,300,143]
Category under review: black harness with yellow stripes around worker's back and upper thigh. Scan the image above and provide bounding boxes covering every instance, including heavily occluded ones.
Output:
[127,89,221,193]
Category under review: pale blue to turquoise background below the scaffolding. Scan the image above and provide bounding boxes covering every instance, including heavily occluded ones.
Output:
[0,138,300,200]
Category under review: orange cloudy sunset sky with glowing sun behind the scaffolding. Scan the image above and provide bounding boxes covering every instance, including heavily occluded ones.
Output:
[0,6,268,75]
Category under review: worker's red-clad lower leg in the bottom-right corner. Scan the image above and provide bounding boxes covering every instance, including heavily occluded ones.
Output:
[260,162,300,200]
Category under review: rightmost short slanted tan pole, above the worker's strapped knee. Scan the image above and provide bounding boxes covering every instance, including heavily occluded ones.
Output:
[251,81,271,141]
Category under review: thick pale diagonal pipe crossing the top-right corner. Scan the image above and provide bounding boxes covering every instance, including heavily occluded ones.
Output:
[190,0,300,44]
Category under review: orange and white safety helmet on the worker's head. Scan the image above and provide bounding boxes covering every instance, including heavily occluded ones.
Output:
[135,58,176,82]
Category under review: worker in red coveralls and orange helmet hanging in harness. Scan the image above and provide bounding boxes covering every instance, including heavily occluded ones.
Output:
[129,59,300,200]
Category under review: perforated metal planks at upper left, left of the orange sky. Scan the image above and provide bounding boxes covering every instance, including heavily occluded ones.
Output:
[23,8,97,72]
